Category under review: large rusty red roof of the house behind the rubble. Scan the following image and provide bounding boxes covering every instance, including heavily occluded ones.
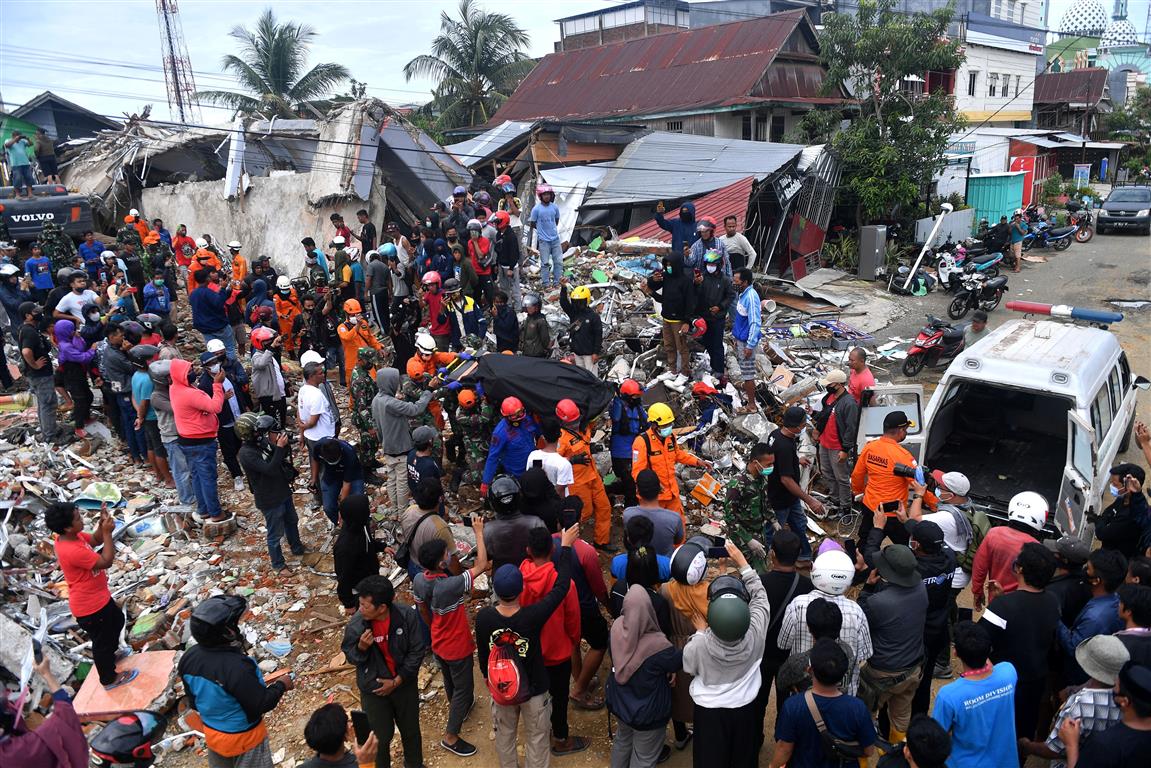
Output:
[489,10,824,126]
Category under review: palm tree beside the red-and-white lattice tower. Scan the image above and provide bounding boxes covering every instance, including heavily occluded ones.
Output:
[196,8,350,117]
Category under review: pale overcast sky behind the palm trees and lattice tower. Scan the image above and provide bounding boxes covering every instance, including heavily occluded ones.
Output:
[0,0,1149,123]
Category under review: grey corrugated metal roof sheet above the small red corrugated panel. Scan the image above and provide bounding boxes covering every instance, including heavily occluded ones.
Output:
[584,131,805,207]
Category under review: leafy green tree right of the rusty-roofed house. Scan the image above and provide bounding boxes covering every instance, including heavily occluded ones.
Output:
[803,0,963,223]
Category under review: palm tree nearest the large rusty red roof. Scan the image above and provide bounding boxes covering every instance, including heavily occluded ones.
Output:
[404,0,533,128]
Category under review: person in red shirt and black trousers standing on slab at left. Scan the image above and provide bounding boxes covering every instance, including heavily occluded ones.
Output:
[44,501,137,691]
